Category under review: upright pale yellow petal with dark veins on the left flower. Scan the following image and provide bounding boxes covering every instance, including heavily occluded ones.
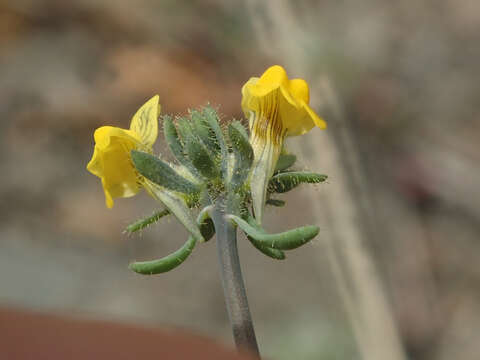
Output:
[130,95,160,148]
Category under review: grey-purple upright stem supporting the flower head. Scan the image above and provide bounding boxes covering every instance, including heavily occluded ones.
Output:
[212,198,260,358]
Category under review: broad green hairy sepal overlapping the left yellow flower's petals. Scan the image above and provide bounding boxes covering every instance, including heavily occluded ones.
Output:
[131,150,200,194]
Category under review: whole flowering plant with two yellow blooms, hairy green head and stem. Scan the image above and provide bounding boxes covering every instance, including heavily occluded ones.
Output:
[87,65,327,358]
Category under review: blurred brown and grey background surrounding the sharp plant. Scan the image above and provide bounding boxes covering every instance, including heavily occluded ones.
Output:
[0,0,480,360]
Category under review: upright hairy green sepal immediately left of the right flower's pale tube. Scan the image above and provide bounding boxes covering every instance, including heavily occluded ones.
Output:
[228,123,253,190]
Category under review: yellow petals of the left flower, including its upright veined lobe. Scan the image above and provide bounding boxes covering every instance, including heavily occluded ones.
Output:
[87,95,160,208]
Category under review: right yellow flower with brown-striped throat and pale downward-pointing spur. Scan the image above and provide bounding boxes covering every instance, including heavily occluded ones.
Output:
[242,65,327,223]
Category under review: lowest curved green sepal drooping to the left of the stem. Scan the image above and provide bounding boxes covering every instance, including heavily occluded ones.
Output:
[128,235,196,275]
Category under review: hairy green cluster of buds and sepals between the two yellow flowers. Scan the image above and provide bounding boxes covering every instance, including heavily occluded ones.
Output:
[126,106,327,274]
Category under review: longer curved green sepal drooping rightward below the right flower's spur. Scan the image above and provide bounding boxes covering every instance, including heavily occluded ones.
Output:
[227,215,320,250]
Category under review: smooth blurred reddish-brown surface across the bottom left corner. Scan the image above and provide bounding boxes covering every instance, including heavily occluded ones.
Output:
[0,309,253,360]
